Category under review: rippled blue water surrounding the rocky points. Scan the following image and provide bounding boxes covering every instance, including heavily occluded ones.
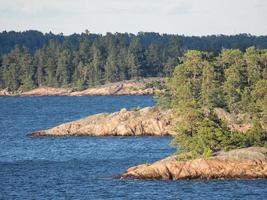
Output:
[0,96,267,200]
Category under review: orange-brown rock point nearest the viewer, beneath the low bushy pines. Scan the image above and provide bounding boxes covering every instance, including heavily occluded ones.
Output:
[119,147,267,180]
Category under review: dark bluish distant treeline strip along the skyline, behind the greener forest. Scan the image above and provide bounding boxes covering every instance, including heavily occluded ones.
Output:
[0,30,267,56]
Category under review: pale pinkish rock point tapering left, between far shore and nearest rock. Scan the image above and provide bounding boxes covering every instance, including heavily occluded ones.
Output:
[29,107,174,136]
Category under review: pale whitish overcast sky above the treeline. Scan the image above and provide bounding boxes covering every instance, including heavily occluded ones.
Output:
[0,0,267,35]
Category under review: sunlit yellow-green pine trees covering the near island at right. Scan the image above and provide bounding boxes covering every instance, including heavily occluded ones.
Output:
[158,47,267,159]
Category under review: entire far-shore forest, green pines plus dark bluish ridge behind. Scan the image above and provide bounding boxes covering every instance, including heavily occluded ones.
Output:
[0,31,267,91]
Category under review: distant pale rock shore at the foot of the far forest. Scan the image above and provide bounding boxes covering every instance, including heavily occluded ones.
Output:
[0,78,162,96]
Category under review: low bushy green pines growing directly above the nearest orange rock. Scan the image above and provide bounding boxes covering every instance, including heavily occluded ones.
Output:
[173,114,267,159]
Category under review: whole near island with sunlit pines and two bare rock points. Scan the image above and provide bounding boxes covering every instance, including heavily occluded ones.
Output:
[29,47,267,180]
